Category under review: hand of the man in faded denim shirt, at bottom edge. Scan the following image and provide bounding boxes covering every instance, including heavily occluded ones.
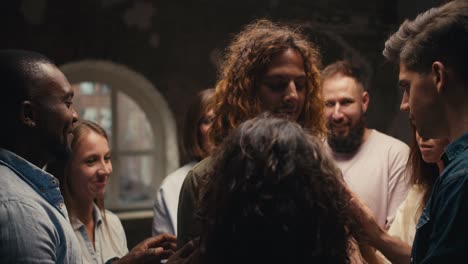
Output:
[112,234,177,264]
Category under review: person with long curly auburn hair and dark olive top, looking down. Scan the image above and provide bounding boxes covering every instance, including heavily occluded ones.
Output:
[177,20,326,247]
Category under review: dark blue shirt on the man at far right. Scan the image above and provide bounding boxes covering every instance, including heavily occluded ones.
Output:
[411,132,468,263]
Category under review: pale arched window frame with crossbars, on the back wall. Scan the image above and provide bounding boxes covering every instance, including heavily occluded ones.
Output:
[59,60,179,212]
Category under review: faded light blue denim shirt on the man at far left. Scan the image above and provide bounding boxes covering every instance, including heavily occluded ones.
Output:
[0,148,82,263]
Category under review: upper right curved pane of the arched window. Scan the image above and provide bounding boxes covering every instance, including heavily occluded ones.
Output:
[117,92,154,151]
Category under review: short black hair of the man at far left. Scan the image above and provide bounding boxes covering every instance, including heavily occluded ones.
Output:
[0,49,54,140]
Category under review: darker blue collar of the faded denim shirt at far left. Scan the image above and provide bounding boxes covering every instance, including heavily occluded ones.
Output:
[0,148,68,219]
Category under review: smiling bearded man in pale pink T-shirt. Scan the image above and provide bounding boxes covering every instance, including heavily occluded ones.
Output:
[322,61,409,228]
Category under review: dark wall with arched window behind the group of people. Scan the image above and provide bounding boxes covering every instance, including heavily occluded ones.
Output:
[0,0,443,248]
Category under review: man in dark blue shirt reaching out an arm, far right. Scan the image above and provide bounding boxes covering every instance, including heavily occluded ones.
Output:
[355,0,468,263]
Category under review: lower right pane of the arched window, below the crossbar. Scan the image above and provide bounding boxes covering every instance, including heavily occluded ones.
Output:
[119,155,156,202]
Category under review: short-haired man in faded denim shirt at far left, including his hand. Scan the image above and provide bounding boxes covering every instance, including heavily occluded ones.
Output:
[0,50,175,263]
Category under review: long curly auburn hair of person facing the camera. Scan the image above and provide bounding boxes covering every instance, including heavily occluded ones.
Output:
[210,19,326,145]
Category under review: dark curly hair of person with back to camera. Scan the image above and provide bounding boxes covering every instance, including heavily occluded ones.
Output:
[198,114,353,264]
